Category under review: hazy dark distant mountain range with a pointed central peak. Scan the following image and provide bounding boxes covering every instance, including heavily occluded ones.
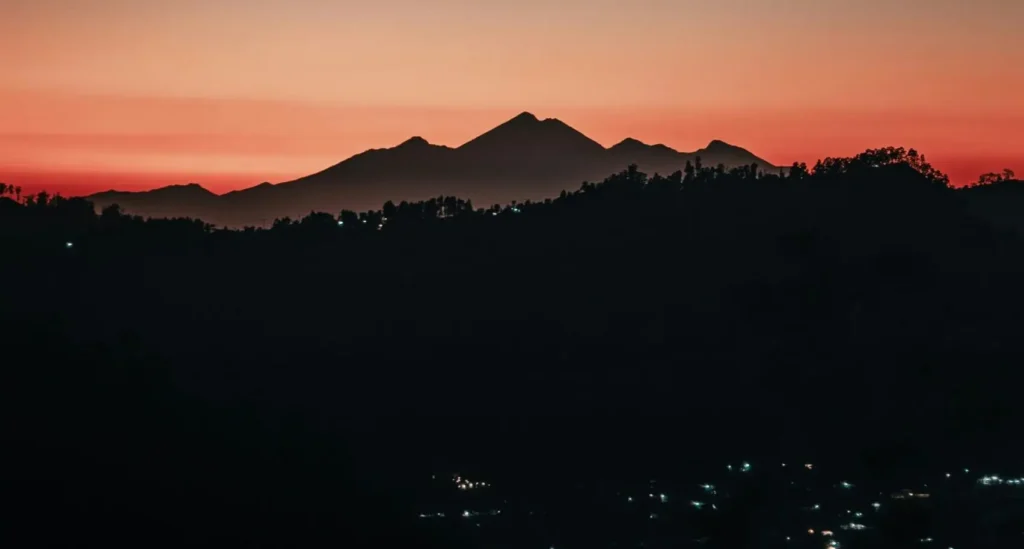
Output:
[88,113,777,226]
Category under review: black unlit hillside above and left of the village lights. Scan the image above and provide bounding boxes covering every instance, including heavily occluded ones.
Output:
[0,150,1024,547]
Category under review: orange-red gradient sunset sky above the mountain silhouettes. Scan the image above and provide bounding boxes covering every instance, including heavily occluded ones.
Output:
[0,0,1024,195]
